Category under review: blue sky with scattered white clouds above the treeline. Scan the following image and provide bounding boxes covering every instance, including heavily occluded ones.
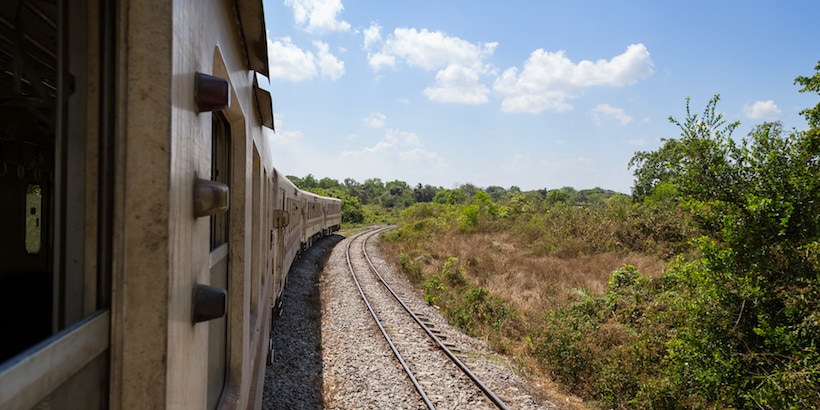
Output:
[260,0,820,193]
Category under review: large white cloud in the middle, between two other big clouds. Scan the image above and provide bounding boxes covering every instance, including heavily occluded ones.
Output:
[365,27,498,104]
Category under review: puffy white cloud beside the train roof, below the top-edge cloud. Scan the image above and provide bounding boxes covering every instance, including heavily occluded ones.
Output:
[268,37,345,82]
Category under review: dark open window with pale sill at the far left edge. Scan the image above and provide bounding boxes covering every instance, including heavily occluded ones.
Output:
[0,0,116,408]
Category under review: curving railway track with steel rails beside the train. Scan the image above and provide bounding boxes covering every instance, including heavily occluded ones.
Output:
[345,228,507,409]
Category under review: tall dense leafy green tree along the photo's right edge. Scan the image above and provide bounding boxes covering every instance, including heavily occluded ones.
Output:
[662,96,820,408]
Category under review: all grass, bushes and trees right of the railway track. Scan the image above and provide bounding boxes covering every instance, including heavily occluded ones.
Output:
[383,64,820,409]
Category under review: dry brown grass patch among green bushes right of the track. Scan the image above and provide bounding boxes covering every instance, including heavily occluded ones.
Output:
[381,226,668,409]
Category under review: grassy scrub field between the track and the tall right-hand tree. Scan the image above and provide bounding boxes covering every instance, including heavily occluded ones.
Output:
[383,197,695,408]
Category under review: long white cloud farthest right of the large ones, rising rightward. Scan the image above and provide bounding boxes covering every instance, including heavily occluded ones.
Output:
[493,44,654,114]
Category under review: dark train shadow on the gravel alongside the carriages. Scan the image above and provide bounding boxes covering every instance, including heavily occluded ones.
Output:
[263,235,344,409]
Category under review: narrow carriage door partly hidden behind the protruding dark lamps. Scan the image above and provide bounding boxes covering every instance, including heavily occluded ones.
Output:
[208,112,231,409]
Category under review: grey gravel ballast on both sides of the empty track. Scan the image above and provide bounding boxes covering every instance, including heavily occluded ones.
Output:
[263,231,555,409]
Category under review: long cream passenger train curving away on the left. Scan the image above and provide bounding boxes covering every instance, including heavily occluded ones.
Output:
[0,0,342,409]
